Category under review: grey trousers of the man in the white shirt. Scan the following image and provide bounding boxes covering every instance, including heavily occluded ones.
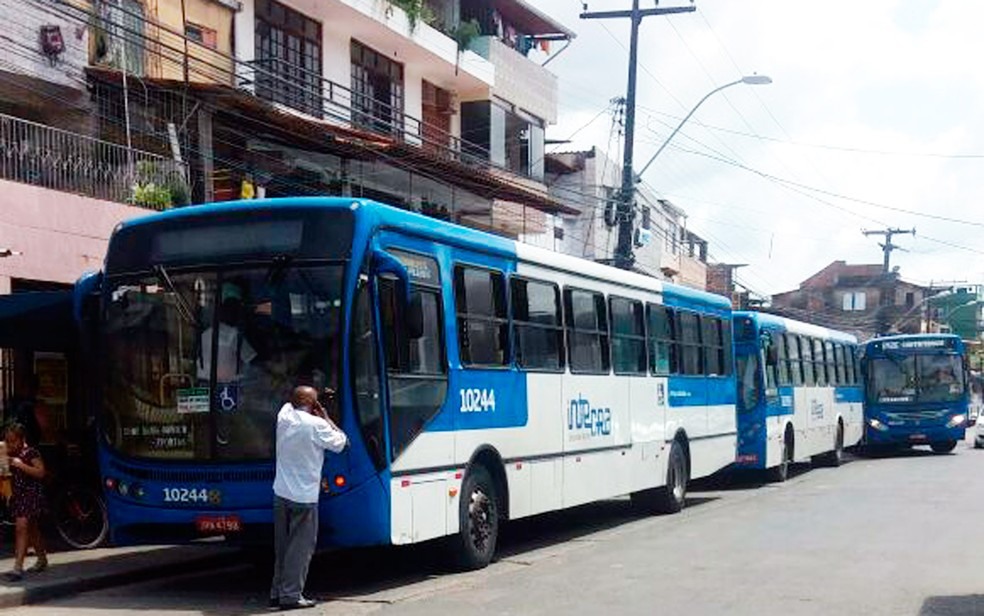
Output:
[270,496,318,605]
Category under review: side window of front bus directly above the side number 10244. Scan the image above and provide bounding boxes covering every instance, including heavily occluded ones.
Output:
[454,265,510,367]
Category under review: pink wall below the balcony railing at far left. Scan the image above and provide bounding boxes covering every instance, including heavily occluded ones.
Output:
[0,180,151,293]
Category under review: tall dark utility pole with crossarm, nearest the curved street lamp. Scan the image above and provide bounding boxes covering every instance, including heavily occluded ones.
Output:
[581,0,697,269]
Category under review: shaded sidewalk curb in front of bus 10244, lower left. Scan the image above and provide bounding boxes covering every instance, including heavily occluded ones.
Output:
[0,551,243,609]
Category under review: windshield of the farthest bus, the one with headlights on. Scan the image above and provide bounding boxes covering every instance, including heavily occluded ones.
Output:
[868,355,964,403]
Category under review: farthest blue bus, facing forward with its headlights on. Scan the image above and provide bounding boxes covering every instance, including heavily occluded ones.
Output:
[862,334,979,453]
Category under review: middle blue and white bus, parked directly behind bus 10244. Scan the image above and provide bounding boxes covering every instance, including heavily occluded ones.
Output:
[734,312,863,481]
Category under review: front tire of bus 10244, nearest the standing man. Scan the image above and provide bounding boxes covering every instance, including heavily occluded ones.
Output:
[450,465,499,571]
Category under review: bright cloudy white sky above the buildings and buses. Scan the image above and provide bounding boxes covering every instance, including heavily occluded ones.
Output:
[536,0,984,295]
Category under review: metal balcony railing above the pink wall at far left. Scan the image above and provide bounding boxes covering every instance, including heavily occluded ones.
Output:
[0,114,181,207]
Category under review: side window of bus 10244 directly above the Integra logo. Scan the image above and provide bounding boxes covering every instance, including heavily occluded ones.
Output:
[564,289,611,374]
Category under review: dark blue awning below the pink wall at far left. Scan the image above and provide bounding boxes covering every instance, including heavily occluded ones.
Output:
[0,291,78,351]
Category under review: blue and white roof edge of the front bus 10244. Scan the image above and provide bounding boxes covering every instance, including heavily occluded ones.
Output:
[117,197,731,310]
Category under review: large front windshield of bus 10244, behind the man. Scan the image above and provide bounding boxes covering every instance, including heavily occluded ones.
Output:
[100,262,343,461]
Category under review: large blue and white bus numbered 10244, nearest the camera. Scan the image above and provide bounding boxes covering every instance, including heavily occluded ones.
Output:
[88,198,736,568]
